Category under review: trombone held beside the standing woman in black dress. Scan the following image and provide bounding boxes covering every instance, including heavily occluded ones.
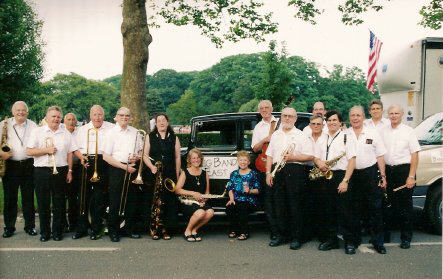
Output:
[119,130,146,217]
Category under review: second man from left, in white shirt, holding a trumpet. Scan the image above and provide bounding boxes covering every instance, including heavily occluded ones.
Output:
[26,106,77,242]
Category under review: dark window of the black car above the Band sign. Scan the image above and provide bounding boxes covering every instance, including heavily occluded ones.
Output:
[195,120,237,151]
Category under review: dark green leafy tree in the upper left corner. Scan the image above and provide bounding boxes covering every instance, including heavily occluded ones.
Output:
[0,0,44,115]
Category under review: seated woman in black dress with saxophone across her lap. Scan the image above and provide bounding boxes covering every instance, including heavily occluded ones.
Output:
[175,148,214,242]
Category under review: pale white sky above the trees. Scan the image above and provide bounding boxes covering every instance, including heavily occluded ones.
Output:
[33,0,443,80]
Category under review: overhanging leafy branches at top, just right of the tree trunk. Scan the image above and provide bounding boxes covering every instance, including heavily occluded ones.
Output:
[149,0,277,47]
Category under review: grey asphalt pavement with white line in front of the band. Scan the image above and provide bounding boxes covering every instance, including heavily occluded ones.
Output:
[0,219,442,279]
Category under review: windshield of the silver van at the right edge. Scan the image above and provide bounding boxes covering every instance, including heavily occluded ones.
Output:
[415,112,443,145]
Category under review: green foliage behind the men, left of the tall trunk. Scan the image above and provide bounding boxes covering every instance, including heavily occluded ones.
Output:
[29,73,120,121]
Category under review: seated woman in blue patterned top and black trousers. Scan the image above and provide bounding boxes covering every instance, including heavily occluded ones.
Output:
[226,151,260,240]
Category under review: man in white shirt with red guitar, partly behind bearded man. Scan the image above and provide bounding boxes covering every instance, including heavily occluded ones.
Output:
[251,100,278,239]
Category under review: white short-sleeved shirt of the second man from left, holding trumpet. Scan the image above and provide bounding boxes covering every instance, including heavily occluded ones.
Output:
[26,125,77,167]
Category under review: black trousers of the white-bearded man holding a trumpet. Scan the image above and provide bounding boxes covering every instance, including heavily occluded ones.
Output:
[273,163,306,240]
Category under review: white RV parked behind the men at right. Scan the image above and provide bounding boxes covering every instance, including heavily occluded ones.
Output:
[377,37,443,127]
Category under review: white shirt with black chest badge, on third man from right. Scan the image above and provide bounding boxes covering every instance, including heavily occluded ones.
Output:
[346,126,386,170]
